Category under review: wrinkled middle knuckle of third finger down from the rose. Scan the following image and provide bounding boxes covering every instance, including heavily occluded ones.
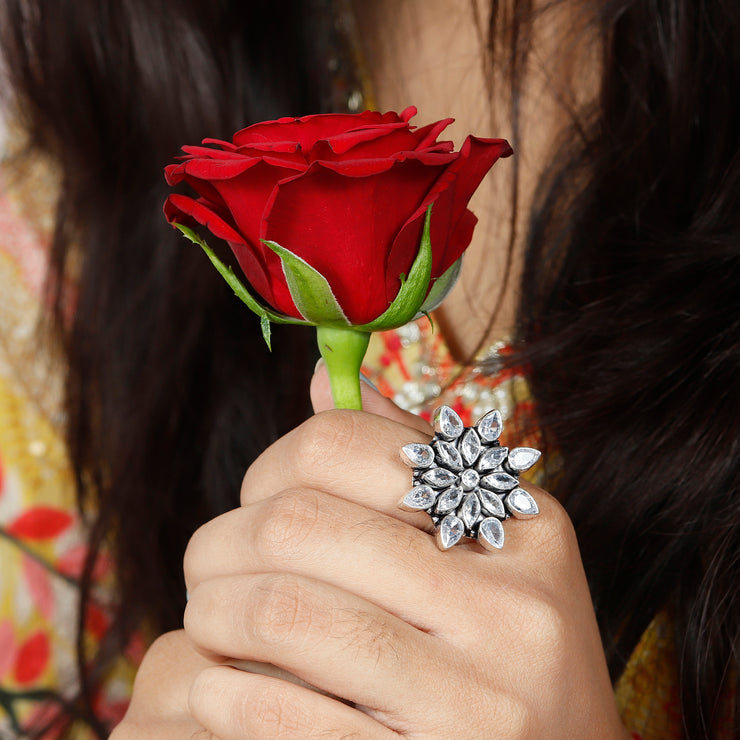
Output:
[251,574,321,644]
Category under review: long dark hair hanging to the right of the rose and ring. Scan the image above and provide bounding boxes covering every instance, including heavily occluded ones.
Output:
[491,0,740,738]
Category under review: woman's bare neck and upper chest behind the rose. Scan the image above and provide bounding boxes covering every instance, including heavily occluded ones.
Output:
[355,0,594,361]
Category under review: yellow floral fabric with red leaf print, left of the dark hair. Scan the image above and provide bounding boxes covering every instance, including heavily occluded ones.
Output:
[0,137,142,740]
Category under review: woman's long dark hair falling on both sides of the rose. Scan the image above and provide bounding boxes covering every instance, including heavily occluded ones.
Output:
[0,0,740,738]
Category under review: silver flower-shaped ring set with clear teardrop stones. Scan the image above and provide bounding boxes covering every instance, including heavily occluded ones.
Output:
[399,406,541,550]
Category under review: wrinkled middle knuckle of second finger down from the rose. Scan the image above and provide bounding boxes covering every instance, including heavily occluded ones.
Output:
[255,489,323,560]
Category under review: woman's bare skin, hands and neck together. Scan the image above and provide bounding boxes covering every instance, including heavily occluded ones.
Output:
[112,0,630,740]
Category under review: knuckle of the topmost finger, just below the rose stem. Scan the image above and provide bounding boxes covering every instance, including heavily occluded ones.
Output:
[294,409,356,480]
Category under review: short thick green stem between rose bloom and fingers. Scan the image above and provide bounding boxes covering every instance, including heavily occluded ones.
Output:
[316,326,370,409]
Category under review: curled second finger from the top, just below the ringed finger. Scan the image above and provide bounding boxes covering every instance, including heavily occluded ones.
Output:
[185,489,480,638]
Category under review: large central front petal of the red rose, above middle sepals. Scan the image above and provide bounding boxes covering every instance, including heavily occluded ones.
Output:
[261,159,443,324]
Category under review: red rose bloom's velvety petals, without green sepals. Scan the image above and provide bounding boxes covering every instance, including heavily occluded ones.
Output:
[164,108,511,325]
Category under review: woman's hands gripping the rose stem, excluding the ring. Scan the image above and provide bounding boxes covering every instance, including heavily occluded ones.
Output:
[114,374,628,740]
